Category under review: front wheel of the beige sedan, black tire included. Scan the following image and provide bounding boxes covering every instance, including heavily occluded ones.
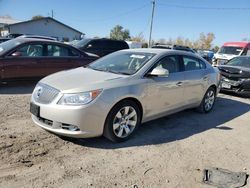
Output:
[103,100,141,142]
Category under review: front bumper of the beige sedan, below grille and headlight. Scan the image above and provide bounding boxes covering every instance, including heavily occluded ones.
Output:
[31,94,109,138]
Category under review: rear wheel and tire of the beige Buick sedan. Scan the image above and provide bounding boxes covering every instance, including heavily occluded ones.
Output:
[197,87,216,113]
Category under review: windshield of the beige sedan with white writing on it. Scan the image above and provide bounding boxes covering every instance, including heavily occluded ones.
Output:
[88,52,155,75]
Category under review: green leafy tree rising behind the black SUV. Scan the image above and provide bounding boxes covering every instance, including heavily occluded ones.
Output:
[110,25,131,40]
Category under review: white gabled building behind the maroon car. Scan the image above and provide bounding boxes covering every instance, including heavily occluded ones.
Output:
[7,17,84,41]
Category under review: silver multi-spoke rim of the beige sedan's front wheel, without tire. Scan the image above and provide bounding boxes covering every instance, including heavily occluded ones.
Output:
[113,106,137,138]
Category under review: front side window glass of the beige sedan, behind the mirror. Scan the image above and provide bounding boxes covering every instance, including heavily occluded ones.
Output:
[154,56,180,73]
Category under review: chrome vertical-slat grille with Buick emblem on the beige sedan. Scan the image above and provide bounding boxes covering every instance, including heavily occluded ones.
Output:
[33,84,59,104]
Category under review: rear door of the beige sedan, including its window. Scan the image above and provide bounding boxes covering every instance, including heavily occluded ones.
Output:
[182,56,210,105]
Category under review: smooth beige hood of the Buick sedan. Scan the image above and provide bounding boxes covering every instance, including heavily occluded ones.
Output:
[40,67,129,93]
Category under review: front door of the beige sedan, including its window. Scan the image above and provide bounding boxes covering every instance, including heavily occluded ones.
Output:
[145,55,184,117]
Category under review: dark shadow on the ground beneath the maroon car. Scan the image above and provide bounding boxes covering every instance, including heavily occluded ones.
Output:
[0,81,37,95]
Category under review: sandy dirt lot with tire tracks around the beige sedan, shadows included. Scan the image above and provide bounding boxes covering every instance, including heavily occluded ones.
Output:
[0,84,250,188]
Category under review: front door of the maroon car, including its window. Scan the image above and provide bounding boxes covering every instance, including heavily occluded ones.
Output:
[2,43,45,79]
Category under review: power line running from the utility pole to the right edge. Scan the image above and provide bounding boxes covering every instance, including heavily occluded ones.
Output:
[158,3,250,10]
